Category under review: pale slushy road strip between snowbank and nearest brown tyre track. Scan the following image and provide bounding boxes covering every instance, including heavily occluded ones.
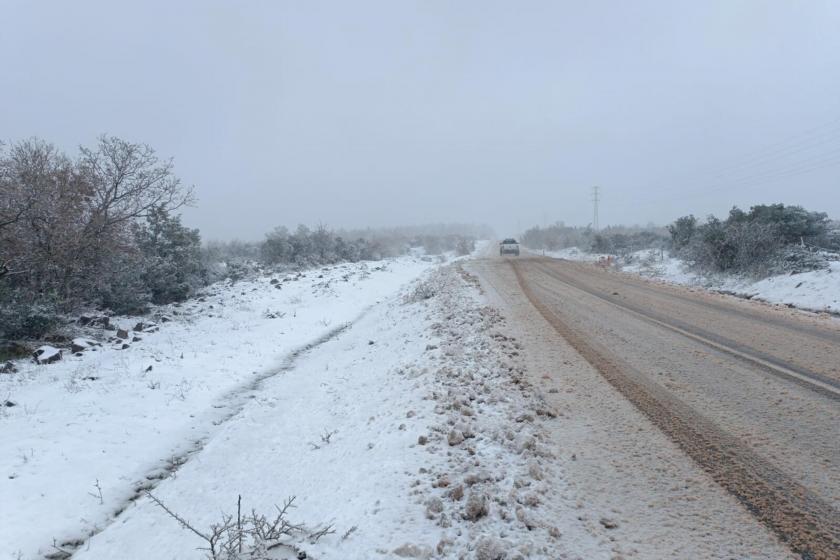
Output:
[467,259,794,559]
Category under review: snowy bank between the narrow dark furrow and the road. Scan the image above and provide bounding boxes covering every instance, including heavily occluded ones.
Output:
[11,265,574,560]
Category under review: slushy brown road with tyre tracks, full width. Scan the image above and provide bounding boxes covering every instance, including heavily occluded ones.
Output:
[470,257,840,558]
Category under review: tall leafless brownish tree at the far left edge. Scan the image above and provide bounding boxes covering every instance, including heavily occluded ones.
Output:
[0,136,193,318]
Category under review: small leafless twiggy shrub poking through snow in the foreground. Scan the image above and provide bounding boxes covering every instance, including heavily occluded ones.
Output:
[146,492,334,560]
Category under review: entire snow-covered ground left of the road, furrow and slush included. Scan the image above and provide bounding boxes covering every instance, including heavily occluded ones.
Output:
[0,246,568,560]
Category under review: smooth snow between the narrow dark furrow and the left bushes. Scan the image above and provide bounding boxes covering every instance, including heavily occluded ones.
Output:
[0,257,435,558]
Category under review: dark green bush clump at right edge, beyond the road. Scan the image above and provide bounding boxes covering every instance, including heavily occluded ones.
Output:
[668,204,840,276]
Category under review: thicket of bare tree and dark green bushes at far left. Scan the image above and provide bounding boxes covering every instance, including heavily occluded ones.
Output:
[0,136,205,338]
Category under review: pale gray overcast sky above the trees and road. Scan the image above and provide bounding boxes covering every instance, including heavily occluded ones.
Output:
[0,0,840,239]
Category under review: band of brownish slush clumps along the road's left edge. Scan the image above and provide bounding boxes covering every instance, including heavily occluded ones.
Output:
[404,268,557,560]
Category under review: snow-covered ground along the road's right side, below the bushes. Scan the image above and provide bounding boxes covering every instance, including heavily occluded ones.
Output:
[546,247,840,314]
